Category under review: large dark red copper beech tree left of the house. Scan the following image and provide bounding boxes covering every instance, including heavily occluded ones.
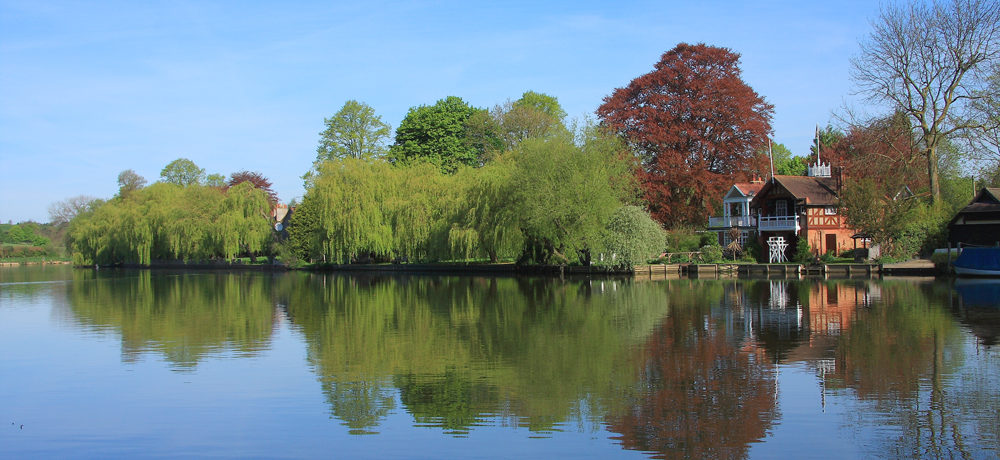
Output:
[597,43,774,226]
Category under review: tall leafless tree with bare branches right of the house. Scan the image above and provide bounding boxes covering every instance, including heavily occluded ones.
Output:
[851,0,1000,203]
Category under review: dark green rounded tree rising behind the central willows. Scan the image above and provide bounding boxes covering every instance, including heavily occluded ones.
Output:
[389,96,481,173]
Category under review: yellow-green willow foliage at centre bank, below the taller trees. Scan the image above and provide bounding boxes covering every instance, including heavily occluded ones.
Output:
[289,122,632,264]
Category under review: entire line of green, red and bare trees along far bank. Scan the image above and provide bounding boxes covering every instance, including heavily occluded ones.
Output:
[58,0,1000,265]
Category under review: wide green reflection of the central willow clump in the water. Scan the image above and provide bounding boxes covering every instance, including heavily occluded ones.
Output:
[287,275,667,434]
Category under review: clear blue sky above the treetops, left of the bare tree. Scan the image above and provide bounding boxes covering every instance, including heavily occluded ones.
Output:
[0,0,878,222]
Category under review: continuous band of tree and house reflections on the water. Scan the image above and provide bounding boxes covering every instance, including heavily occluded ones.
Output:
[48,270,1000,458]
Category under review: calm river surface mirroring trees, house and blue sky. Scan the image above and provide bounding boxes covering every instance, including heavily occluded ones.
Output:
[0,267,1000,458]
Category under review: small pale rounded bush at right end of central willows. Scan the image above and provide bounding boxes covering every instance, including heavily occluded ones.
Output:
[603,206,666,268]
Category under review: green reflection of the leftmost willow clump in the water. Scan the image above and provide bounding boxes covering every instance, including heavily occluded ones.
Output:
[67,270,275,369]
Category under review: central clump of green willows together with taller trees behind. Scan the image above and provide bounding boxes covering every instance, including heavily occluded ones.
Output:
[288,111,664,266]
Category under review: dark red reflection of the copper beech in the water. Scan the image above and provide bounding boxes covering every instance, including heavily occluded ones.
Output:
[610,283,778,458]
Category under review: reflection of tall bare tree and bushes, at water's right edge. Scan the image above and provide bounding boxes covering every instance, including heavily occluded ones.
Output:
[829,282,1000,458]
